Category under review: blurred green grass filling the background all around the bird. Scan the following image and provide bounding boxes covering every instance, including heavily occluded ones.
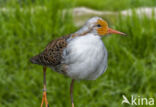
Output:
[0,0,156,107]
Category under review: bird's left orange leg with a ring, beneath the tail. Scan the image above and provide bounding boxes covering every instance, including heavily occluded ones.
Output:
[41,66,49,107]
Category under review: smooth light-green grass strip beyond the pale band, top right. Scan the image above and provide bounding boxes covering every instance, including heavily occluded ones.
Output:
[75,0,156,11]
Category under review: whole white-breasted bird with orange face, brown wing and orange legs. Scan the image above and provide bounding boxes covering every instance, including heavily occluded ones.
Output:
[30,16,126,107]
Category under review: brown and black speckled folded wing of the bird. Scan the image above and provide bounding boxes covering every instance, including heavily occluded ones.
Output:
[30,35,70,66]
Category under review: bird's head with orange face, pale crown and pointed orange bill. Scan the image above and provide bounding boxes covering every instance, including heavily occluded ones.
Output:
[77,17,126,36]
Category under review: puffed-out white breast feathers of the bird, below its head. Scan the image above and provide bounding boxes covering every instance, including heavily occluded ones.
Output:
[63,34,107,80]
